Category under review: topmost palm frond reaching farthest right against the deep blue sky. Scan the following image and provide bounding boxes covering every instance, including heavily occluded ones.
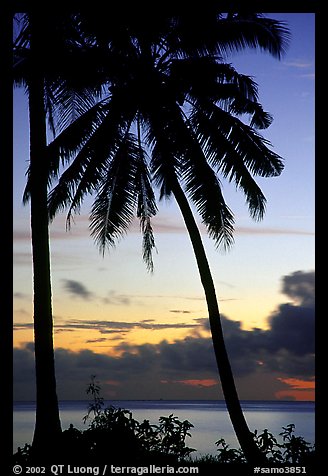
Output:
[166,11,290,58]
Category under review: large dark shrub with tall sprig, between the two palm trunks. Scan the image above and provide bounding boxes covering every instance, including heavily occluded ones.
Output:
[76,376,195,462]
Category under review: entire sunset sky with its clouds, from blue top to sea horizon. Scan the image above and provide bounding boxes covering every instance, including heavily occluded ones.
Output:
[13,13,315,400]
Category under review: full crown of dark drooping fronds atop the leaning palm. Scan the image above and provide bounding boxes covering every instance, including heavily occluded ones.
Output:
[20,10,289,264]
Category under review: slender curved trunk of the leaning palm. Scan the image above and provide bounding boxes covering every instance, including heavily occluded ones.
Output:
[172,180,267,464]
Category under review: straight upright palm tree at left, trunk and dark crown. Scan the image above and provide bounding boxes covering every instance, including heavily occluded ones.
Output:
[13,12,104,455]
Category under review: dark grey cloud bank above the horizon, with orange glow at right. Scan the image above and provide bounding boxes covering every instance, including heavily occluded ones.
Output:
[14,271,314,399]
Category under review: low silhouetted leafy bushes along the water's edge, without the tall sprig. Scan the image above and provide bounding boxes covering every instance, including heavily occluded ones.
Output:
[14,406,315,466]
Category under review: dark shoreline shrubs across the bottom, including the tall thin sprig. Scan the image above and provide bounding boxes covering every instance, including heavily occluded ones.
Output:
[13,380,315,475]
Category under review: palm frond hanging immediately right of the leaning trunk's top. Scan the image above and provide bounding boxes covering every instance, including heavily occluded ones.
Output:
[152,100,234,248]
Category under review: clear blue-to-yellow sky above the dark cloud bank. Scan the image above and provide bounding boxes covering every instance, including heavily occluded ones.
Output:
[13,13,315,398]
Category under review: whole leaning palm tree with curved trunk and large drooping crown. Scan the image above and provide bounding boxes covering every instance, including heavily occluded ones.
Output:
[47,8,287,463]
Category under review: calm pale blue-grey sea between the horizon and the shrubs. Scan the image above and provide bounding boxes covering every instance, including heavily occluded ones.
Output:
[13,400,315,456]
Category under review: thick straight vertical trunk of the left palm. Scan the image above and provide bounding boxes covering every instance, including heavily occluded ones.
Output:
[29,15,61,456]
